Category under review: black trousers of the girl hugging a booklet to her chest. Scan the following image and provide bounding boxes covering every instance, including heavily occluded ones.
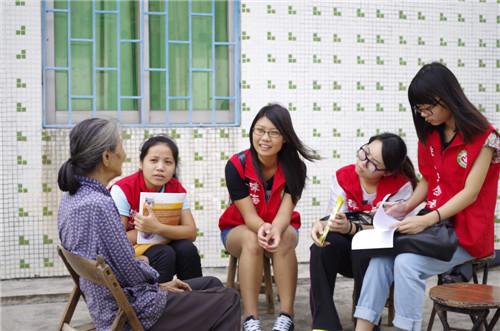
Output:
[144,239,202,283]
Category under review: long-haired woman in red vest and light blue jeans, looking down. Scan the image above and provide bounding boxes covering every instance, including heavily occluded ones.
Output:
[354,63,500,331]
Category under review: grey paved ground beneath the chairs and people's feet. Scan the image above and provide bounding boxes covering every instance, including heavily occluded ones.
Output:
[1,264,500,331]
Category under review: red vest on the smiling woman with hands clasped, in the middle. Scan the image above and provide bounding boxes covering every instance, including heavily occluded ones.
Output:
[219,149,300,231]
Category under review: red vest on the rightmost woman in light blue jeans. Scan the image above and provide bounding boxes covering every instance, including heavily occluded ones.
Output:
[418,127,500,258]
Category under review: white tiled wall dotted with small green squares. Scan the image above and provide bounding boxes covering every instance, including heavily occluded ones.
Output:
[0,0,500,278]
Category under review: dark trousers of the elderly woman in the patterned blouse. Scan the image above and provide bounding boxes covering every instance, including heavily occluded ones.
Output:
[150,277,241,331]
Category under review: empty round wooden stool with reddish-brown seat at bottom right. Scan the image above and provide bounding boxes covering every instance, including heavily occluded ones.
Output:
[429,283,500,331]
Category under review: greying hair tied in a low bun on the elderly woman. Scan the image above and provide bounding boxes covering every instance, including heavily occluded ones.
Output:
[57,118,120,195]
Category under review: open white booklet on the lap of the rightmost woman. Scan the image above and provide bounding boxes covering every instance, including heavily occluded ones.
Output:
[351,194,399,250]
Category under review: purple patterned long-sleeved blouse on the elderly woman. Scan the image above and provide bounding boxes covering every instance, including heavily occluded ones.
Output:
[57,177,167,330]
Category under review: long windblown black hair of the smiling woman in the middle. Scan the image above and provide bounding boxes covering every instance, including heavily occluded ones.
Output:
[250,104,319,203]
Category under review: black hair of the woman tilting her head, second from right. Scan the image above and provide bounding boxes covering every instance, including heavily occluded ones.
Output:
[368,132,418,188]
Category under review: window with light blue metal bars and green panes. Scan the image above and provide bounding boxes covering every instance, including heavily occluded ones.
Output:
[42,0,240,127]
